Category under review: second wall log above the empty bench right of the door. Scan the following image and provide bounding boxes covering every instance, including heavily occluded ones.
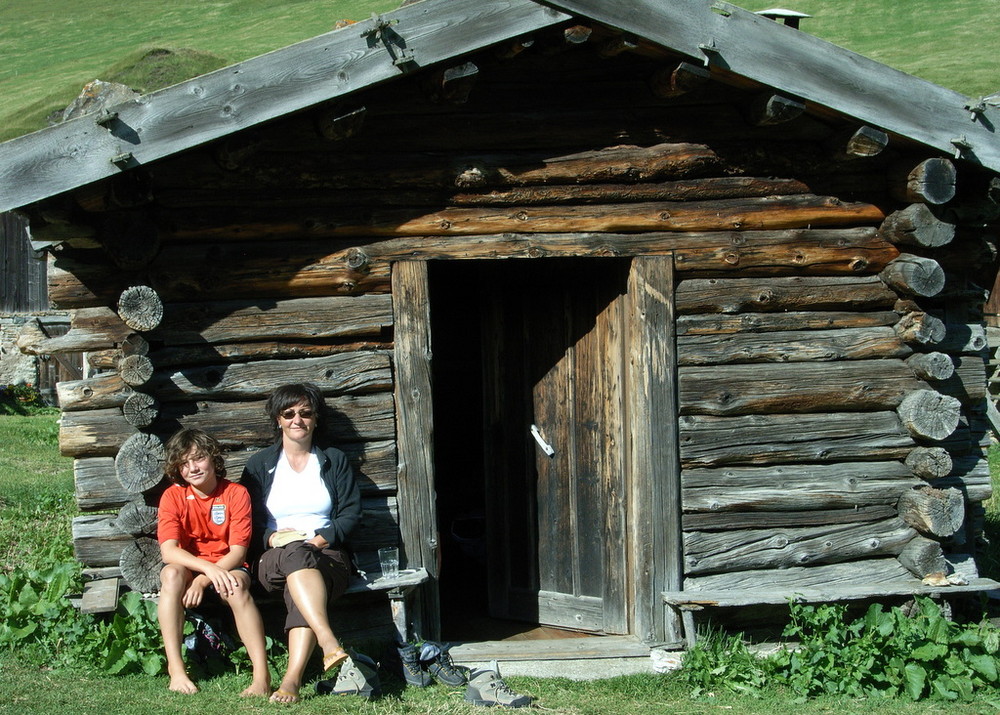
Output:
[684,518,916,575]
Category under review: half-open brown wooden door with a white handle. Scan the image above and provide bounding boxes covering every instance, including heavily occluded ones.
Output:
[482,259,629,633]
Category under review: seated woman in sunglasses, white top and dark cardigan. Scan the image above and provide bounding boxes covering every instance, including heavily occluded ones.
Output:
[241,383,361,703]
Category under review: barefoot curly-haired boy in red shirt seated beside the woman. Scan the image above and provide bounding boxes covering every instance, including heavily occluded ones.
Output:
[157,429,271,697]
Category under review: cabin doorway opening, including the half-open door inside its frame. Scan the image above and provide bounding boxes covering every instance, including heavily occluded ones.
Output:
[428,258,630,640]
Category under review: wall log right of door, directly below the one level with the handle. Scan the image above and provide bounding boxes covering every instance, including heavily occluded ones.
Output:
[681,461,922,512]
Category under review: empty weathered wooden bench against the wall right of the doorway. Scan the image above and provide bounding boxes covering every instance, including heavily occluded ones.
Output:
[660,578,1000,648]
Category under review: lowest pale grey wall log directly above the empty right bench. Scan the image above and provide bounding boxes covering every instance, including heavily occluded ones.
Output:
[684,560,917,598]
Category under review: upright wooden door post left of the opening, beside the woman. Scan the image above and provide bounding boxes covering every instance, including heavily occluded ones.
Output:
[392,261,441,639]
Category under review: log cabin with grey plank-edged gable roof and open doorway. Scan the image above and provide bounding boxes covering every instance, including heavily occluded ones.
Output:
[0,0,1000,655]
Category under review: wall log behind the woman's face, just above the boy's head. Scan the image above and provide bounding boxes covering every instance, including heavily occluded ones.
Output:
[59,394,396,457]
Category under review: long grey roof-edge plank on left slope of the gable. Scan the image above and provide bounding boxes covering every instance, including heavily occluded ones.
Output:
[0,0,568,211]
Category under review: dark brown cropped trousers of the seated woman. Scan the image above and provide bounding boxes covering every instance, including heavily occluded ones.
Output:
[257,541,351,631]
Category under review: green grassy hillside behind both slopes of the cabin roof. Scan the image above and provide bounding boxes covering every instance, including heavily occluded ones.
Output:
[0,0,1000,140]
